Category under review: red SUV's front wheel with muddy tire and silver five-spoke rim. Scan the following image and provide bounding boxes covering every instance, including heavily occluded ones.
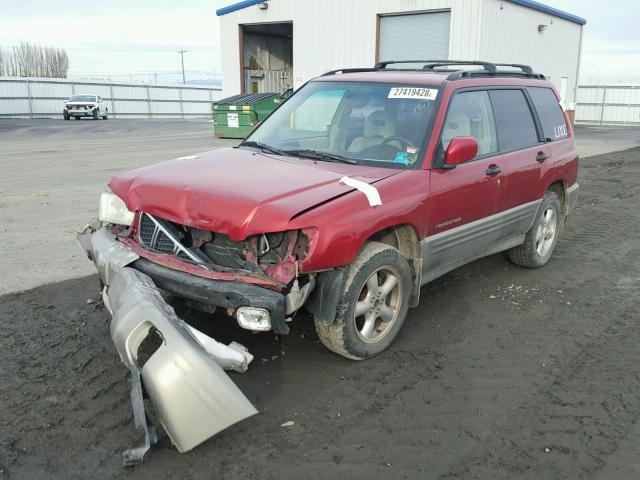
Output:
[315,242,412,360]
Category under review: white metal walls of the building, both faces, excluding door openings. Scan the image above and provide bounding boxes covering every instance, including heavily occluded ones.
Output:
[220,0,581,102]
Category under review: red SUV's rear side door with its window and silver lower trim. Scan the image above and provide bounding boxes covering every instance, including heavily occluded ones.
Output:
[489,88,549,241]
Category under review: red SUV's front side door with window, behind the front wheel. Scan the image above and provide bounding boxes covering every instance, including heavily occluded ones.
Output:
[423,90,506,282]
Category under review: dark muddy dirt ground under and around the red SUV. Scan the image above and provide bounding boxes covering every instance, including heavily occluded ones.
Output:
[0,137,640,480]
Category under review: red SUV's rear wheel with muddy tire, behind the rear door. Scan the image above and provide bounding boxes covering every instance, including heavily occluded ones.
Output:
[509,191,562,268]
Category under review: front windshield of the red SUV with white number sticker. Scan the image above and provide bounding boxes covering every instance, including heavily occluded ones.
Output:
[245,81,438,167]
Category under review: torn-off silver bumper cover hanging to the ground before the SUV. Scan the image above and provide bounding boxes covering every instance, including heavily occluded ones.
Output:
[78,223,257,465]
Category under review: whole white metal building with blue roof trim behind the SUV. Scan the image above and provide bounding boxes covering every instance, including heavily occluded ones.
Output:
[217,0,586,116]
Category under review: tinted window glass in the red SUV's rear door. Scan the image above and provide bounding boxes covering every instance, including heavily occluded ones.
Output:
[489,90,539,152]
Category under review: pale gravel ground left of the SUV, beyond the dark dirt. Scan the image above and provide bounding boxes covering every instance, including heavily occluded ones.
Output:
[0,119,238,295]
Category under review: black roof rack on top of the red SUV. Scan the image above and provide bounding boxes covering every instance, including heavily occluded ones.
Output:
[322,60,545,80]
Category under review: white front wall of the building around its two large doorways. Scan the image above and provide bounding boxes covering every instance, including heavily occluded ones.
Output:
[220,0,481,96]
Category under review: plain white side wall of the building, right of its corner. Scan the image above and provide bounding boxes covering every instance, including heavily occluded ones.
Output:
[479,0,582,106]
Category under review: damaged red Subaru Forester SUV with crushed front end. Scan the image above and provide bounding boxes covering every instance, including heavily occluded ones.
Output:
[82,61,578,462]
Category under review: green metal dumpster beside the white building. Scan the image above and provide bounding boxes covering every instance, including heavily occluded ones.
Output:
[212,93,283,138]
